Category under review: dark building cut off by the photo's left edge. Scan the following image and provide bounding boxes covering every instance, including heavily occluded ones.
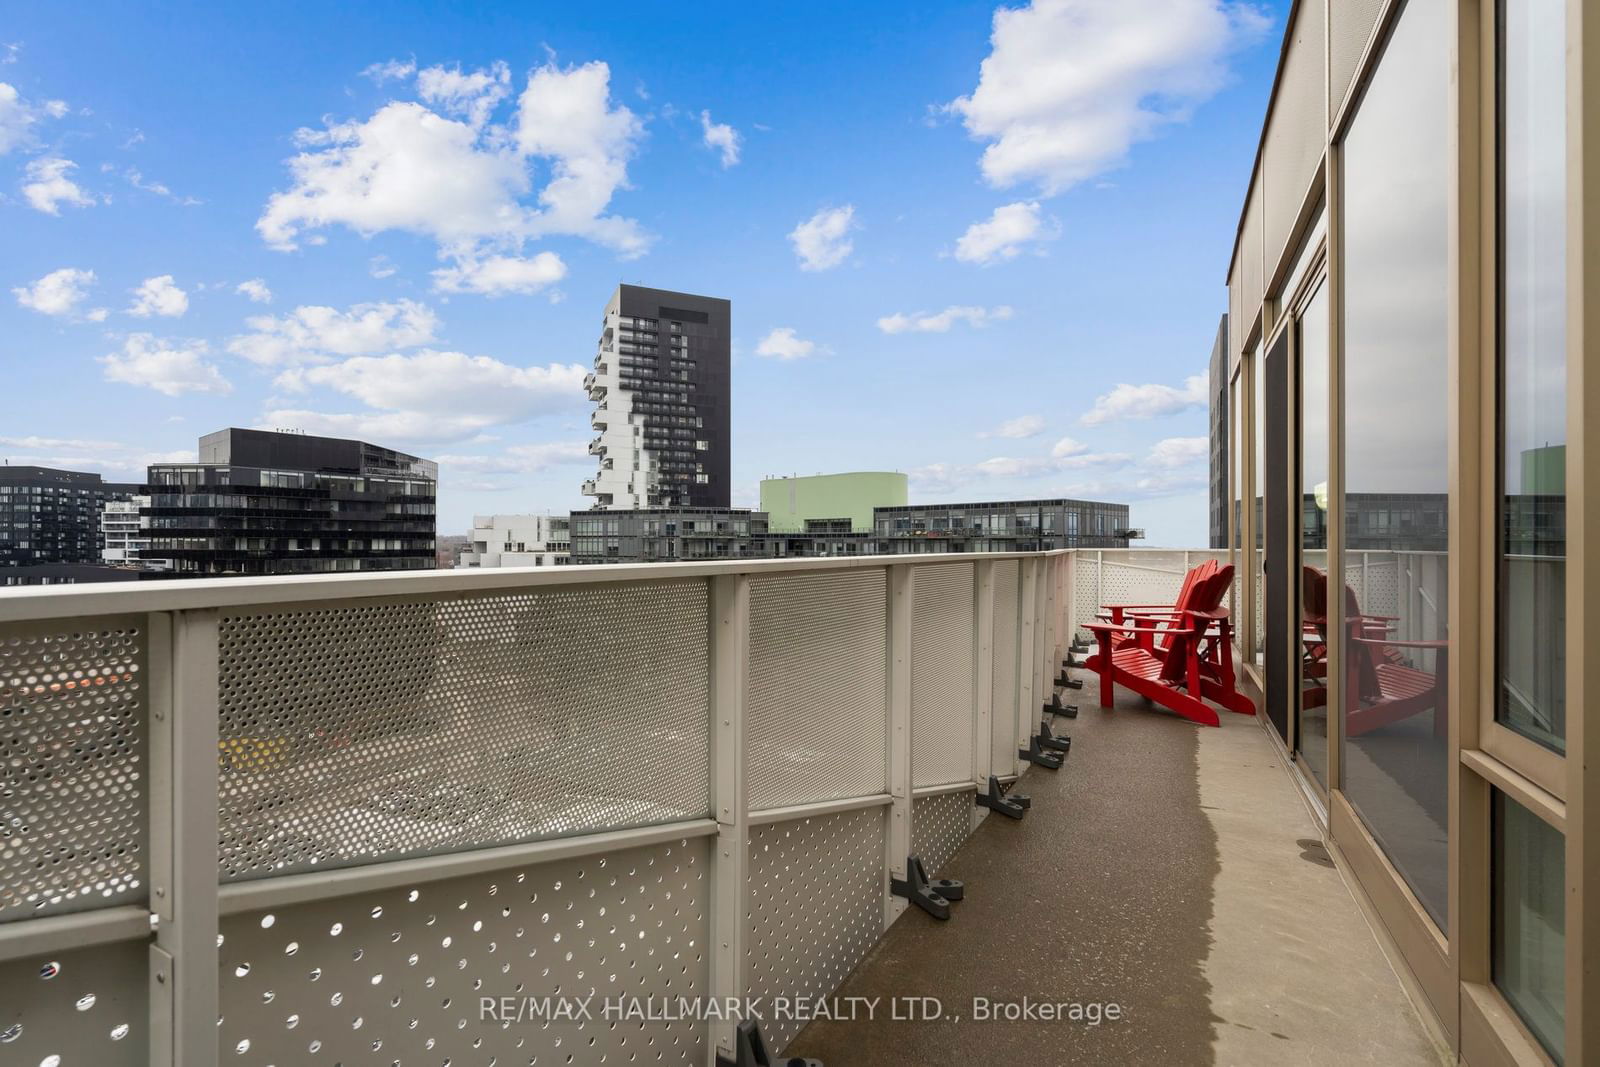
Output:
[0,466,138,577]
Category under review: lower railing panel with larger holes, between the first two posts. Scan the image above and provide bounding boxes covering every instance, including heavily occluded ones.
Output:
[218,838,709,1065]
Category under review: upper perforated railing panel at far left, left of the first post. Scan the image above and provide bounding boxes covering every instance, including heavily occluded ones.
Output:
[0,616,149,923]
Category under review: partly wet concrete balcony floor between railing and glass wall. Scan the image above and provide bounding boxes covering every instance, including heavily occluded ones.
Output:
[786,678,1450,1067]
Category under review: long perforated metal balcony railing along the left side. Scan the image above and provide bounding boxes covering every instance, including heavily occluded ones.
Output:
[0,553,1072,1067]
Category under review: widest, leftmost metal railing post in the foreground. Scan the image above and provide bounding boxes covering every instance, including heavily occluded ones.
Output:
[147,609,219,1067]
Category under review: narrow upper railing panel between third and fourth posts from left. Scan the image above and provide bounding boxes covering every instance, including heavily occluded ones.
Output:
[910,563,976,787]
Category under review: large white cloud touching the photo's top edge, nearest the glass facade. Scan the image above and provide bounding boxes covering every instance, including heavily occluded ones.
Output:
[949,0,1270,195]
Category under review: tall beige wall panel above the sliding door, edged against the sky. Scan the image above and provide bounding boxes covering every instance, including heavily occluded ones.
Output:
[1261,3,1328,278]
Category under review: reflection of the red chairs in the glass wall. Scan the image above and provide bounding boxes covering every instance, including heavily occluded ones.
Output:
[1301,566,1450,737]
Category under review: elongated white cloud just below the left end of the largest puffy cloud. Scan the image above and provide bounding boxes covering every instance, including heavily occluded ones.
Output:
[227,299,438,366]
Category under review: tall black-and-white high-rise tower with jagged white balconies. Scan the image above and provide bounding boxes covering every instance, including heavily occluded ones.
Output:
[582,285,731,510]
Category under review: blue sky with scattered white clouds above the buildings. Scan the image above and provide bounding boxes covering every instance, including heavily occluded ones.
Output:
[0,0,1283,545]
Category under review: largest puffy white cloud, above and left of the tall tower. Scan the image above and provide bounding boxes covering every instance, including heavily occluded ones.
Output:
[256,62,650,275]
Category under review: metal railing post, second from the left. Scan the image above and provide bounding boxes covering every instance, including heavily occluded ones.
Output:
[706,574,750,1067]
